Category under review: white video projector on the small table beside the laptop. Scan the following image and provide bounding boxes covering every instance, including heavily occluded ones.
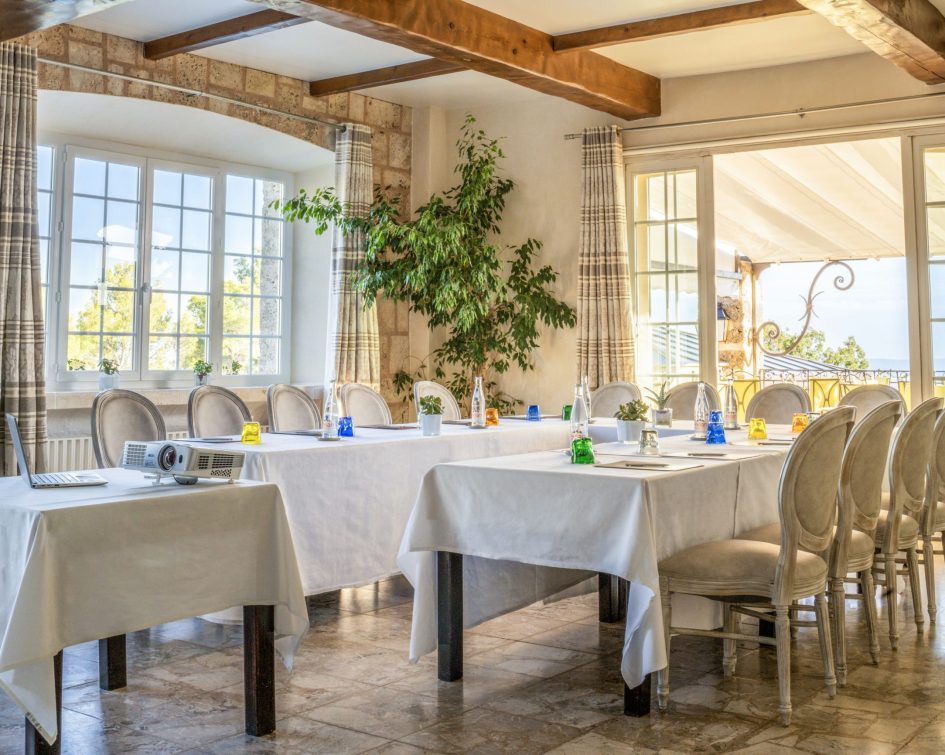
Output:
[121,440,244,485]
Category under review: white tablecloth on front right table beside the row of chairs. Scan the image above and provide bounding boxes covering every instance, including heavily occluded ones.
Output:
[397,427,787,686]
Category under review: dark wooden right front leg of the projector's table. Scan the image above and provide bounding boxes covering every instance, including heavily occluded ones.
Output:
[243,606,276,737]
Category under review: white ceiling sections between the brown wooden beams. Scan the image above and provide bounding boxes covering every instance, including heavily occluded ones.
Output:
[76,0,876,108]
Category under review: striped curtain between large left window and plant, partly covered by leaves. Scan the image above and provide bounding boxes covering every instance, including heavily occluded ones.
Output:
[327,123,381,390]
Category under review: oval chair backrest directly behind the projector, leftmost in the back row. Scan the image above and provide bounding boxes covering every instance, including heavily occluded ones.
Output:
[92,388,167,469]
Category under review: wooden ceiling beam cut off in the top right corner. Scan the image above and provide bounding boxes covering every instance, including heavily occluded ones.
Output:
[800,0,945,84]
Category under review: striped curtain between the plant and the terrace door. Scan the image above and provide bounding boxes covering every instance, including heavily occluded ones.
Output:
[577,126,634,390]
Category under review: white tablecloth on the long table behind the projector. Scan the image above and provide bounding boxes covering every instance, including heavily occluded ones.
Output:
[232,420,569,595]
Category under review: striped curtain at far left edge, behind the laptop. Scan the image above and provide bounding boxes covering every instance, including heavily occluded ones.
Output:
[0,42,46,475]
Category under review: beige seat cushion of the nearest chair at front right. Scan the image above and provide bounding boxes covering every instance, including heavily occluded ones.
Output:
[659,539,827,597]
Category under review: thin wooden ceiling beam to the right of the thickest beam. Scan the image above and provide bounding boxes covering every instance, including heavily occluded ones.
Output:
[554,0,810,52]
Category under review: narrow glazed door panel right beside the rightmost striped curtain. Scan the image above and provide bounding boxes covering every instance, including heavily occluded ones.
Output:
[631,170,700,385]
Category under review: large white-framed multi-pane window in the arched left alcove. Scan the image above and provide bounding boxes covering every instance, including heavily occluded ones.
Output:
[45,145,287,387]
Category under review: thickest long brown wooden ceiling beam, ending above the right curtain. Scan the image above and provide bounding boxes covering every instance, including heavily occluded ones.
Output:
[255,0,660,120]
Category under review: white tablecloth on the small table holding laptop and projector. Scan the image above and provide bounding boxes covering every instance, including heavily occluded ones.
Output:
[0,469,308,742]
